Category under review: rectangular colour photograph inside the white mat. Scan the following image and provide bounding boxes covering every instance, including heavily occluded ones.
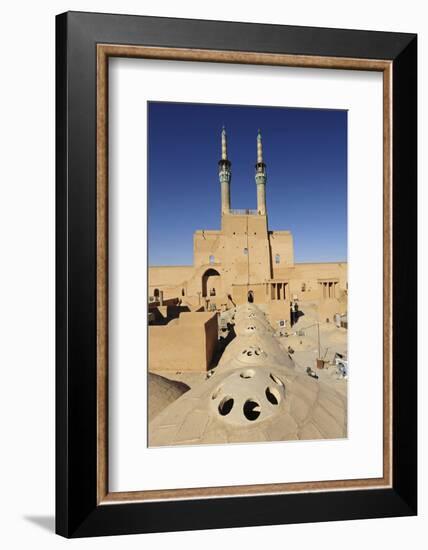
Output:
[147,101,352,447]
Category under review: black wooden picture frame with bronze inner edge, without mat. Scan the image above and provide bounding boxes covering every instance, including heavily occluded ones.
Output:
[56,12,417,537]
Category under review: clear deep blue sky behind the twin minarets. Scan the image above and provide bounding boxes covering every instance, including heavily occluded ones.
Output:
[148,102,347,265]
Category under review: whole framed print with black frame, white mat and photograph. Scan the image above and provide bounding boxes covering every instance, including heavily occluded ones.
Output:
[56,12,417,537]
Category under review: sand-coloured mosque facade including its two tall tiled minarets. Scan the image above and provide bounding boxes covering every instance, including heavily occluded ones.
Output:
[148,128,348,320]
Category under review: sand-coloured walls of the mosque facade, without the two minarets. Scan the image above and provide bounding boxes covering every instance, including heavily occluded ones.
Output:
[149,220,347,309]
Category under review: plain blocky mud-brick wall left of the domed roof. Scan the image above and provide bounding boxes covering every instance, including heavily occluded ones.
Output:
[149,312,218,372]
